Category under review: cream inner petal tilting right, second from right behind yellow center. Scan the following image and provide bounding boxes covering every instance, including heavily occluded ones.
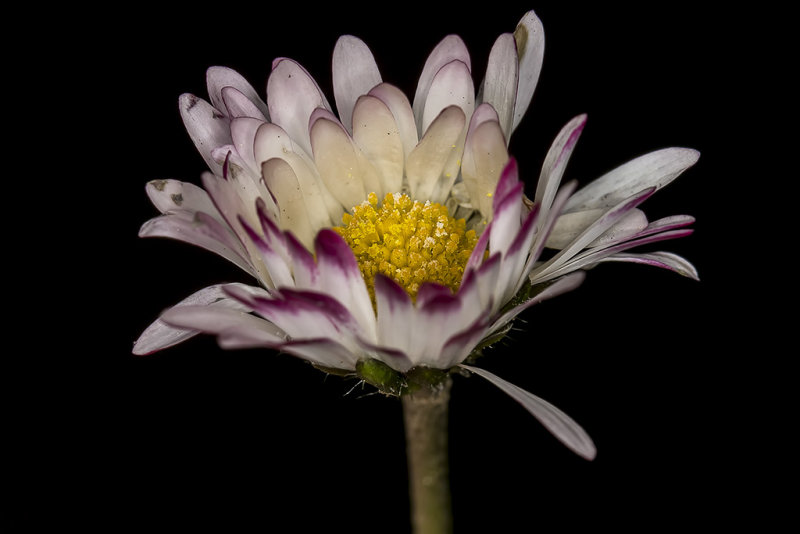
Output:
[406,106,466,200]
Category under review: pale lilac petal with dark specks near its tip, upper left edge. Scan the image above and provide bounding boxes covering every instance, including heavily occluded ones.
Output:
[178,94,231,174]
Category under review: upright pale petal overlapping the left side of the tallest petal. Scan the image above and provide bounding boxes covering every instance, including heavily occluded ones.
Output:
[481,33,519,139]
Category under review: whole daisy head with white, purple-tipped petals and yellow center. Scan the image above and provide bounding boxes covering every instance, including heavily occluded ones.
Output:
[134,8,697,457]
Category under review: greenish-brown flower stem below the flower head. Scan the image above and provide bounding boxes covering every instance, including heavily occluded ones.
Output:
[402,377,453,534]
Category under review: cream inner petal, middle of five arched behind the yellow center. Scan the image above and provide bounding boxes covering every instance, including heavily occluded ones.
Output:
[353,96,405,196]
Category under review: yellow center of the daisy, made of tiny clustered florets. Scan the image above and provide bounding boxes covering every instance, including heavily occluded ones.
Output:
[334,193,478,302]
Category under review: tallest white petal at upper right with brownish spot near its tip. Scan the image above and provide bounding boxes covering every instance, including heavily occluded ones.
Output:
[512,11,544,131]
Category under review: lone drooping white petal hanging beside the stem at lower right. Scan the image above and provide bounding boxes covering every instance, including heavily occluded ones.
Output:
[461,365,597,460]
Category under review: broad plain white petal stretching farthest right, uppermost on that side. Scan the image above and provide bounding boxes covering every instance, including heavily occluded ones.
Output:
[565,148,700,212]
